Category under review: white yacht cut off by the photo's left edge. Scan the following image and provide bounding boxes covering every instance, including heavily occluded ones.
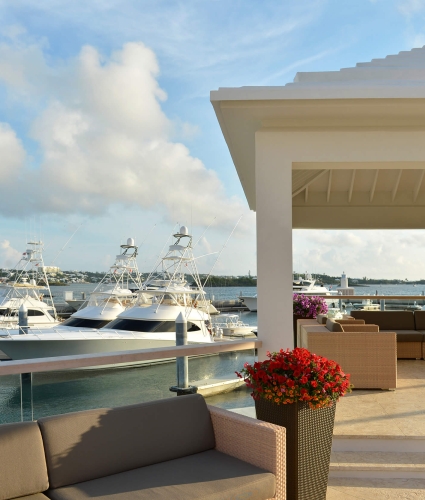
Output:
[0,241,59,334]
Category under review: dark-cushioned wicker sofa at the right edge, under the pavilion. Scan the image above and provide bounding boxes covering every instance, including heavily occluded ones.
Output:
[351,311,425,359]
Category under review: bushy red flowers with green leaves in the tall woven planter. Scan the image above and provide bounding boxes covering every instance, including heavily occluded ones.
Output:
[236,347,351,409]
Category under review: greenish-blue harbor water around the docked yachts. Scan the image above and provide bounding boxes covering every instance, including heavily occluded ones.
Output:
[0,284,425,423]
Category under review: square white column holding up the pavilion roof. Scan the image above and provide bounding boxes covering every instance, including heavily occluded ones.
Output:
[255,130,294,360]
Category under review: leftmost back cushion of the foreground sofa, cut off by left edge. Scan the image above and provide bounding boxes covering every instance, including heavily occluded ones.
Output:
[0,422,49,500]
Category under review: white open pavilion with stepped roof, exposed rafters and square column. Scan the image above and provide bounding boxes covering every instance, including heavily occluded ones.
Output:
[211,47,425,356]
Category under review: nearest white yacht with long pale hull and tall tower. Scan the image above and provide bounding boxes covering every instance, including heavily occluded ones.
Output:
[0,226,214,359]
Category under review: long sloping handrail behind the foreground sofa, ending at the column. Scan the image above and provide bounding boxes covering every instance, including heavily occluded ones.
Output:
[0,339,262,376]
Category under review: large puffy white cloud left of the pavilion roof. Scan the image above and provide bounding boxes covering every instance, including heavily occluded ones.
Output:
[0,43,248,229]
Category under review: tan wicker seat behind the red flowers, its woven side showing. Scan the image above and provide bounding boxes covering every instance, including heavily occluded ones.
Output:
[298,319,397,389]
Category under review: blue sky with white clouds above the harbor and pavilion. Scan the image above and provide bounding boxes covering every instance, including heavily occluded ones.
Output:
[0,0,425,279]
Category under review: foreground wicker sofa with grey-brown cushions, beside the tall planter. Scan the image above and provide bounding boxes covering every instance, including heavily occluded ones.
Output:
[0,394,286,500]
